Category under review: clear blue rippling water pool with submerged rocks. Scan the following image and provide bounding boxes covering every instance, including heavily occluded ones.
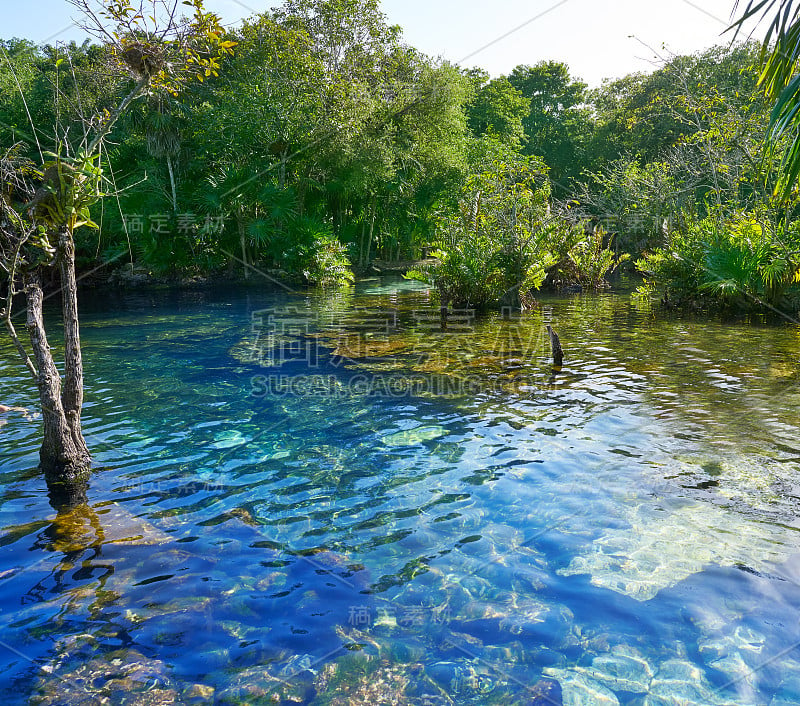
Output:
[0,280,800,706]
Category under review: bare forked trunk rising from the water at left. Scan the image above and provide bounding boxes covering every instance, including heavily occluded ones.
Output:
[25,249,91,492]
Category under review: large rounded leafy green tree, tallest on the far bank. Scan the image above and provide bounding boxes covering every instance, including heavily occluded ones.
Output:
[187,0,469,275]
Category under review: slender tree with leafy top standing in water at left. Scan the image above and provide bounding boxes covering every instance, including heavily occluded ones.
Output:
[0,0,233,495]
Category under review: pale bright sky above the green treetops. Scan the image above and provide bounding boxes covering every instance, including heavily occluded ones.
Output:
[0,0,766,86]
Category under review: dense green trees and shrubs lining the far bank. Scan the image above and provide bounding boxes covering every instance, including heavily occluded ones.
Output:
[0,0,800,311]
